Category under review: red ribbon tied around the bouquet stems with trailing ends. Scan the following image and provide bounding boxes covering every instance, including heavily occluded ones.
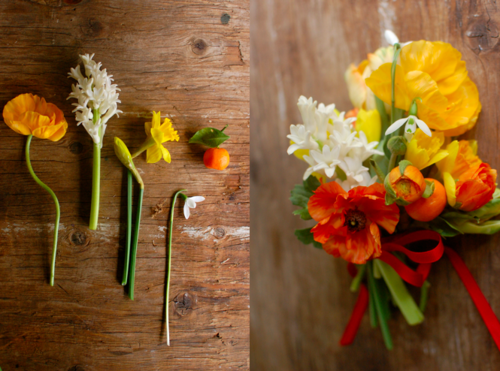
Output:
[340,230,500,350]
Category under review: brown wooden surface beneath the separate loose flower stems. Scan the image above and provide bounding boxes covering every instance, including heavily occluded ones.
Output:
[0,0,250,371]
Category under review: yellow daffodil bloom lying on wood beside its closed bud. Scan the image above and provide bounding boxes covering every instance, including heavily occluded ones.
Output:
[145,111,179,164]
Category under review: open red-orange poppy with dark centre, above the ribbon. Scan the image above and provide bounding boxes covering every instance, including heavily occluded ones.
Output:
[307,182,399,264]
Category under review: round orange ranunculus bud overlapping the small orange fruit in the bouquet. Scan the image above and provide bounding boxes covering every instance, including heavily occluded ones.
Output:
[386,161,426,205]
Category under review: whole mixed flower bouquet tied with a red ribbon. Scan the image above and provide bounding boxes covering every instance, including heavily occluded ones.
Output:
[288,31,500,349]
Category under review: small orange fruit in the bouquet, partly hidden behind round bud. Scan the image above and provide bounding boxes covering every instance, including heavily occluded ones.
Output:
[405,178,446,222]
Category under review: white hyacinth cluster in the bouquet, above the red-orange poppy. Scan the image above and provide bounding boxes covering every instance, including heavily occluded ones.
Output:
[287,96,383,191]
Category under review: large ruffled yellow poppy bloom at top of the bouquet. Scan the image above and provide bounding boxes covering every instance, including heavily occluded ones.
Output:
[366,40,481,136]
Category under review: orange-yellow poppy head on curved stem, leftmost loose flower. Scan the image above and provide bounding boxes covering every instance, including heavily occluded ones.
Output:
[3,94,68,142]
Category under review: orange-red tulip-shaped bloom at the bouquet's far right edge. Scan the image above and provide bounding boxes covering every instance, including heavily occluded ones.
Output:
[455,162,497,211]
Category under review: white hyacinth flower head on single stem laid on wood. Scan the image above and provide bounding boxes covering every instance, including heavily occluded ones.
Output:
[68,54,122,147]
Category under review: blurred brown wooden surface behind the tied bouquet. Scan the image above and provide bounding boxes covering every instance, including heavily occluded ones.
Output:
[250,0,500,371]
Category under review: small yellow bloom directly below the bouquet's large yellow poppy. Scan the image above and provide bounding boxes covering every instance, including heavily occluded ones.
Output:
[405,129,448,170]
